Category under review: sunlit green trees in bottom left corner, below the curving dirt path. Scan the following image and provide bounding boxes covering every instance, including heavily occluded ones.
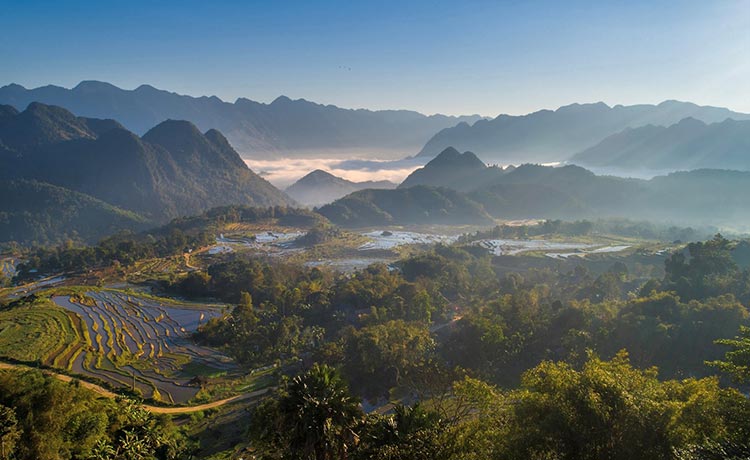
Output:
[0,371,189,460]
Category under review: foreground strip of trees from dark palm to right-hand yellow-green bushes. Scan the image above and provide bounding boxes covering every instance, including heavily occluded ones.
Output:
[251,352,750,460]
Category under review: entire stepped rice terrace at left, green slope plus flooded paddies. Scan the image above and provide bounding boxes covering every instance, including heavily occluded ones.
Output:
[0,289,236,404]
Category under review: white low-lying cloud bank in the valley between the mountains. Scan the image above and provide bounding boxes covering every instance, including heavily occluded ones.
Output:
[245,158,425,189]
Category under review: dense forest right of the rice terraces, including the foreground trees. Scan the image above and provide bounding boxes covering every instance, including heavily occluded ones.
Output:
[214,235,750,459]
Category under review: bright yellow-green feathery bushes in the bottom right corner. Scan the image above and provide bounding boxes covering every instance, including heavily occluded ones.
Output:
[494,353,747,459]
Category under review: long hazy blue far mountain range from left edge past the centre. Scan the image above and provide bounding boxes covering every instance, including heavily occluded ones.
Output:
[0,81,480,158]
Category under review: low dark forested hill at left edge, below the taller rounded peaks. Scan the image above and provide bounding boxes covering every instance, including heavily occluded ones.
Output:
[0,180,146,244]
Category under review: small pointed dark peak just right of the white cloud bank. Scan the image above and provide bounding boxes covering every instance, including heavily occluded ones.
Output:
[399,147,507,191]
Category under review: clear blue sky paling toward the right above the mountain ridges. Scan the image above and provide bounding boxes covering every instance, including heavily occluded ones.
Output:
[0,0,750,115]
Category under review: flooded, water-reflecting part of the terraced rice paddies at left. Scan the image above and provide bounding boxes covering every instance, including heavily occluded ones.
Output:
[50,291,235,403]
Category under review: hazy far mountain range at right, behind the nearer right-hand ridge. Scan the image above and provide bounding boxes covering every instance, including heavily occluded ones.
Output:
[419,101,750,164]
